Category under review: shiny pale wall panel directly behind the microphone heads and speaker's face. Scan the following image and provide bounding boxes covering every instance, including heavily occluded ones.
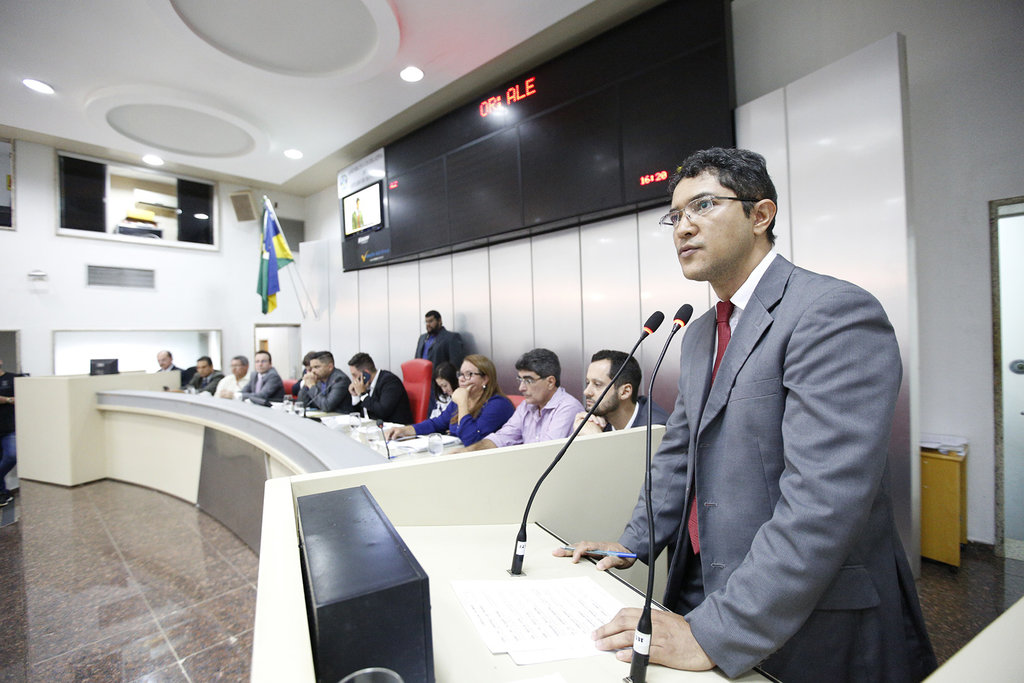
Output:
[637,204,711,412]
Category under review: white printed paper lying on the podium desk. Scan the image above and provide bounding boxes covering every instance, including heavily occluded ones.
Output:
[452,577,623,664]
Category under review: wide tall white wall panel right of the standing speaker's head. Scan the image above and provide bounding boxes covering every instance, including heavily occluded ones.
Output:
[785,34,921,566]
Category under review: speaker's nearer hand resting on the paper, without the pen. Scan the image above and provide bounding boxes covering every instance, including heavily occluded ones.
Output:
[594,606,715,671]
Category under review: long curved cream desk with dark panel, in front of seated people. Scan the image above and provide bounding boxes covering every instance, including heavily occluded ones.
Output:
[16,373,386,552]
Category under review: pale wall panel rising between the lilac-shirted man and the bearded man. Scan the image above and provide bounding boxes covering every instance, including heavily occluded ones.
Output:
[522,229,584,398]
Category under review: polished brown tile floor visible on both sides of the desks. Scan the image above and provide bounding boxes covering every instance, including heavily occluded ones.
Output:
[0,481,1024,683]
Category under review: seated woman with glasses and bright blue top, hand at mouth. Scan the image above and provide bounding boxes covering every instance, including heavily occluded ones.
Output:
[387,353,515,445]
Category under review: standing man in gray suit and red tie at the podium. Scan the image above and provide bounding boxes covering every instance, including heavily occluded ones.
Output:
[555,150,935,681]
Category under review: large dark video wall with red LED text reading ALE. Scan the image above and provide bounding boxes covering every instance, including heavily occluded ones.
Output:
[345,0,734,269]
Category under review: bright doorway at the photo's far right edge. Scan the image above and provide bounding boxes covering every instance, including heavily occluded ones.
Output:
[989,197,1024,560]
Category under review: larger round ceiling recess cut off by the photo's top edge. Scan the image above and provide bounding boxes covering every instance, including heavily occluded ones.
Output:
[170,0,387,76]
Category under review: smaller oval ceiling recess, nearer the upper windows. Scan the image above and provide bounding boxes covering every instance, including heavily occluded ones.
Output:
[106,103,256,157]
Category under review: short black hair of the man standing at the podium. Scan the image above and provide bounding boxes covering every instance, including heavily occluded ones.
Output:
[669,147,778,244]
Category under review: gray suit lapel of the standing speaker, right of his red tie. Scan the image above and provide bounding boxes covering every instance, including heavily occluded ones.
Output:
[697,256,794,437]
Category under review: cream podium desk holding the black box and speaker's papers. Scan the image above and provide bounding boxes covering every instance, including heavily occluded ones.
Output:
[252,426,763,683]
